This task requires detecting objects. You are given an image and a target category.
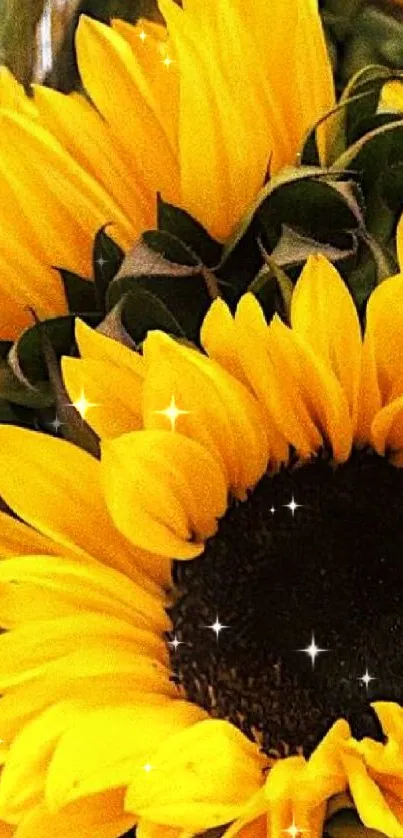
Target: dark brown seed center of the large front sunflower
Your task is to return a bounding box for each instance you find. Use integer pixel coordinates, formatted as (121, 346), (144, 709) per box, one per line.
(170, 453), (403, 756)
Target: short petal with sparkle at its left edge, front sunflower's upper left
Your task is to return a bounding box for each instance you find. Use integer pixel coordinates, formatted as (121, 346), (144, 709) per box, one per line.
(62, 357), (143, 439)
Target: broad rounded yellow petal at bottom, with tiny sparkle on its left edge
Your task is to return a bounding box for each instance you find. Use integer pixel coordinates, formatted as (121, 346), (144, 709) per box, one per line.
(125, 719), (267, 832)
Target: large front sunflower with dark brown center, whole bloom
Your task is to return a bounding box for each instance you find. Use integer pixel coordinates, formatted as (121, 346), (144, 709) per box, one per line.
(0, 256), (403, 838)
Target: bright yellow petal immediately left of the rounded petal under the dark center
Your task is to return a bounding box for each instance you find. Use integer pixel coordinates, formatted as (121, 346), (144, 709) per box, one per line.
(46, 700), (208, 809)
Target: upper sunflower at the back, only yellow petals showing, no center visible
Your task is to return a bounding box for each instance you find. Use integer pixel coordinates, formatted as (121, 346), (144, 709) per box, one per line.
(0, 0), (334, 339)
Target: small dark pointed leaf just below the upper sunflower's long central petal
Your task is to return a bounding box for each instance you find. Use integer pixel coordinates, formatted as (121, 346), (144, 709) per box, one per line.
(157, 195), (222, 268)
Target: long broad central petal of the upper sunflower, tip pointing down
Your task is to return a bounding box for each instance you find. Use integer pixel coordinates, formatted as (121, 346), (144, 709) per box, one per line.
(159, 0), (271, 240)
